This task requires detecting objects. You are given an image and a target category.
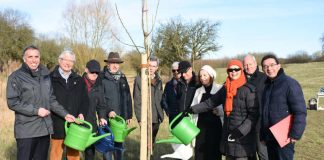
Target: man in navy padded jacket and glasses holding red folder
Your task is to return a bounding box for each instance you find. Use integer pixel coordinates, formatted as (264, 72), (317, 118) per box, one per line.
(261, 54), (306, 160)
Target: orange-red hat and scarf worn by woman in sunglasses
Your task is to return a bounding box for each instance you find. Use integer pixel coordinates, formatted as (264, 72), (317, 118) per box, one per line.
(224, 60), (246, 116)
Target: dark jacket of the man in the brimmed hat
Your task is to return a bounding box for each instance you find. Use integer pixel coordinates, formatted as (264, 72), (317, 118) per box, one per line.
(100, 67), (133, 119)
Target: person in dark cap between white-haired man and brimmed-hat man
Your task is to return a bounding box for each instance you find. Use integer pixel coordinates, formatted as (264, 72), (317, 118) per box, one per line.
(82, 59), (107, 160)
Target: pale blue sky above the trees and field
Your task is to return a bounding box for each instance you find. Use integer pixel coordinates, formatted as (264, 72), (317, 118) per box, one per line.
(0, 0), (324, 59)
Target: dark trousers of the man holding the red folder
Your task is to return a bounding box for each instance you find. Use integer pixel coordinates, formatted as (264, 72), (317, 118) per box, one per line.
(266, 141), (295, 160)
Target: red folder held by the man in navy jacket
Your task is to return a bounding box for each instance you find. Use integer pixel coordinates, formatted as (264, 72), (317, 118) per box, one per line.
(269, 114), (293, 148)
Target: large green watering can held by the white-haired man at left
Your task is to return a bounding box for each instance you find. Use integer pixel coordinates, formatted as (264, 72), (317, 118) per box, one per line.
(64, 118), (110, 151)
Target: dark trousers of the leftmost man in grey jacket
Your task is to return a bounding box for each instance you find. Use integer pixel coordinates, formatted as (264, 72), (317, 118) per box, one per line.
(16, 135), (50, 160)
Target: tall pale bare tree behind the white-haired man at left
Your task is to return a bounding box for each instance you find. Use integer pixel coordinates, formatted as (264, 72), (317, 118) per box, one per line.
(63, 0), (114, 69)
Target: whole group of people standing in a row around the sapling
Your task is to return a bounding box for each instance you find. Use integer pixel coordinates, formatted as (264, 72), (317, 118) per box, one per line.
(7, 45), (306, 160)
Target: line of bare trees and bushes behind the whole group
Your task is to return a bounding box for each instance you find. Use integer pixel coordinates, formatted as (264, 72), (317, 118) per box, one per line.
(0, 4), (324, 74)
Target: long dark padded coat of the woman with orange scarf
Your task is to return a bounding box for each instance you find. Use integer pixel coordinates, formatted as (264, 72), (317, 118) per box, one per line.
(192, 83), (259, 157)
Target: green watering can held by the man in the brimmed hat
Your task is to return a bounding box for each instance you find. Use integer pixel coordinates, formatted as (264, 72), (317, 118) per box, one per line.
(109, 115), (136, 142)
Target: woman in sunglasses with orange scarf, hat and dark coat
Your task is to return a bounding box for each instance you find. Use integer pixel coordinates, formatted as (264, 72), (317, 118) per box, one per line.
(189, 60), (259, 160)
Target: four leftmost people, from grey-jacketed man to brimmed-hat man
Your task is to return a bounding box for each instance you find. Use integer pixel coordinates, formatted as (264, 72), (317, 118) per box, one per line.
(7, 45), (133, 160)
